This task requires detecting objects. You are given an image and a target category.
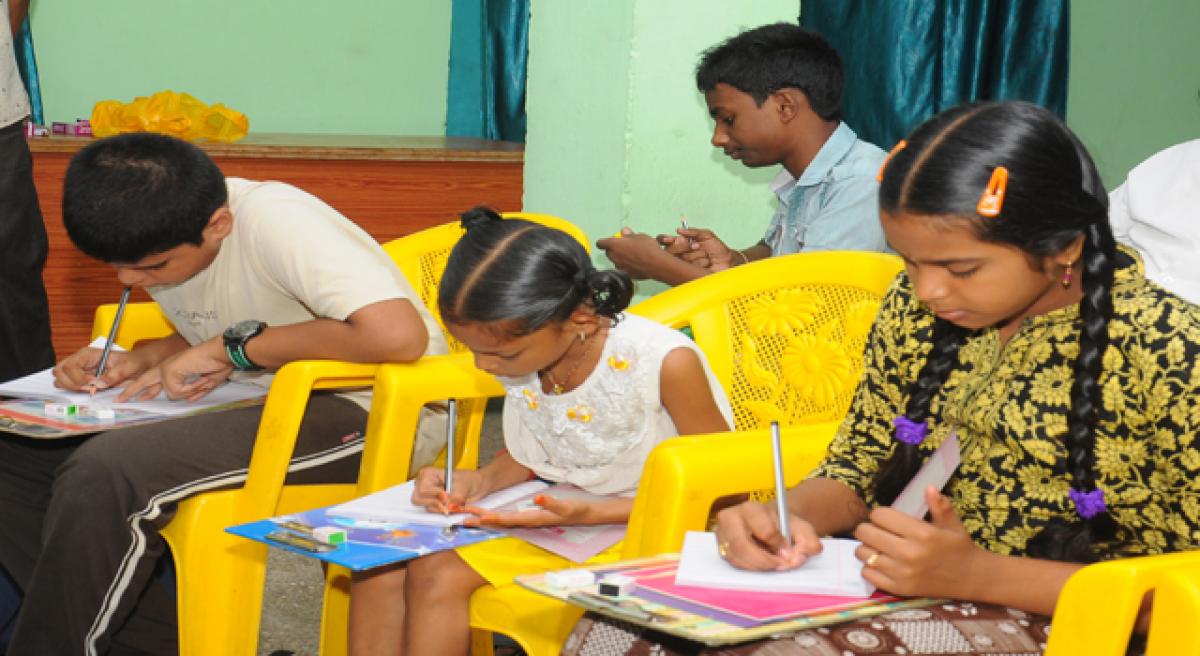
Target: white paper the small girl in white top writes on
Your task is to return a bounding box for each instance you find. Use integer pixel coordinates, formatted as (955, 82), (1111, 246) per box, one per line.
(328, 481), (550, 526)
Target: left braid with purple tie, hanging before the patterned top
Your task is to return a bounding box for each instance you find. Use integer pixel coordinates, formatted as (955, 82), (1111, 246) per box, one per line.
(875, 319), (970, 505)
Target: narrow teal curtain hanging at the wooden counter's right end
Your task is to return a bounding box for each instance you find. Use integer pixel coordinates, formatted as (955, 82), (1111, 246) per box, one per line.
(446, 0), (529, 142)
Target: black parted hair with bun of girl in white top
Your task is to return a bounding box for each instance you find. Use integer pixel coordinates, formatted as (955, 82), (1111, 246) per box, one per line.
(438, 206), (634, 336)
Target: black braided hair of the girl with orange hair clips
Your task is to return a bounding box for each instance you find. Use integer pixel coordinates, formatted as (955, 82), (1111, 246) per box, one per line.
(875, 102), (1117, 562)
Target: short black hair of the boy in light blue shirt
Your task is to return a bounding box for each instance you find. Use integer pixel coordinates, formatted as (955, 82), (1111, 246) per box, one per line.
(696, 23), (842, 121)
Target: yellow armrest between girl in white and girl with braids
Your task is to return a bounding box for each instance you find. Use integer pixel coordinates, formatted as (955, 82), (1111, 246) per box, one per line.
(623, 422), (838, 558)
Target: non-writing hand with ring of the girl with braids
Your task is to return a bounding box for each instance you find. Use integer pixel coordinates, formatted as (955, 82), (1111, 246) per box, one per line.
(854, 486), (989, 598)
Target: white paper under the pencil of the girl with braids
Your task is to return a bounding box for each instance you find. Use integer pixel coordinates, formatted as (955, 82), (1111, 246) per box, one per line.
(676, 531), (875, 597)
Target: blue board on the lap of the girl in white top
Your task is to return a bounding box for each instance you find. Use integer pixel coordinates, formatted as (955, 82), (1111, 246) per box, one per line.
(226, 506), (504, 572)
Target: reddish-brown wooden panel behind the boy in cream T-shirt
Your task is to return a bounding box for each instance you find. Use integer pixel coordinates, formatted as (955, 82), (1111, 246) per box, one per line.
(31, 136), (523, 359)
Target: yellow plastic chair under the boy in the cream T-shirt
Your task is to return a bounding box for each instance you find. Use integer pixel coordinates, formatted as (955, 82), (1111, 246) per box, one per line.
(84, 217), (530, 656)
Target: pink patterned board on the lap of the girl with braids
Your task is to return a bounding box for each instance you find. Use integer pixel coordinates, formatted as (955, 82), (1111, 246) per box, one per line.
(516, 554), (938, 646)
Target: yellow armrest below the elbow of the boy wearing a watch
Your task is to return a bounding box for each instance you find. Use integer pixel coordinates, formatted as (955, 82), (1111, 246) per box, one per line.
(234, 360), (379, 523)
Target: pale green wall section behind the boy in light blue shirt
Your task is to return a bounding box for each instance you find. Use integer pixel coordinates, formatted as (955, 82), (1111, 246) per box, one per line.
(524, 0), (798, 295)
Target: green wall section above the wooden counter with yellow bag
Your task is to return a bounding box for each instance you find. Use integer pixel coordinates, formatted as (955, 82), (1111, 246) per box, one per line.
(31, 0), (450, 134)
